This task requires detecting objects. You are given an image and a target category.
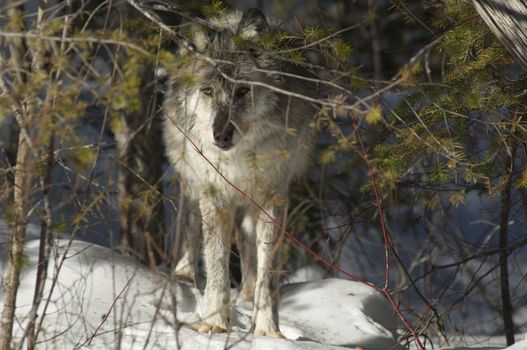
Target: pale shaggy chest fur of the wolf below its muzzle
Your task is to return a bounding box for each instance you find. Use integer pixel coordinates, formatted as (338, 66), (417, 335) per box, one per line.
(165, 121), (306, 205)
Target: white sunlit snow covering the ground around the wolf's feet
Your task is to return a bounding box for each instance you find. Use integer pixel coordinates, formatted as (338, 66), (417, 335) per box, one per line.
(0, 240), (527, 350)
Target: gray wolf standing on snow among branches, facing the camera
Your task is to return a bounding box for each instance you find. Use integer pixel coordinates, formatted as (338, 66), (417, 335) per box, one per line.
(164, 9), (317, 337)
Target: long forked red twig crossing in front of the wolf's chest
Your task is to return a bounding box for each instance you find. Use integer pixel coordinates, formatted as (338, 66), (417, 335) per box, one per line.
(167, 116), (424, 350)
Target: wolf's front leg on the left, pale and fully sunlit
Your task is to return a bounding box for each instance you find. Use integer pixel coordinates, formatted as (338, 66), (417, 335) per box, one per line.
(198, 199), (234, 333)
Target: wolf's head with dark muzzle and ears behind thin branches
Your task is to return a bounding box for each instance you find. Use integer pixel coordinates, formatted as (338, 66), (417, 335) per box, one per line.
(171, 9), (281, 151)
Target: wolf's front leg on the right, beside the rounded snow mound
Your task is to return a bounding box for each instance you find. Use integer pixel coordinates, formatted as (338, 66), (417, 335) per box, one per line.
(253, 208), (282, 337)
